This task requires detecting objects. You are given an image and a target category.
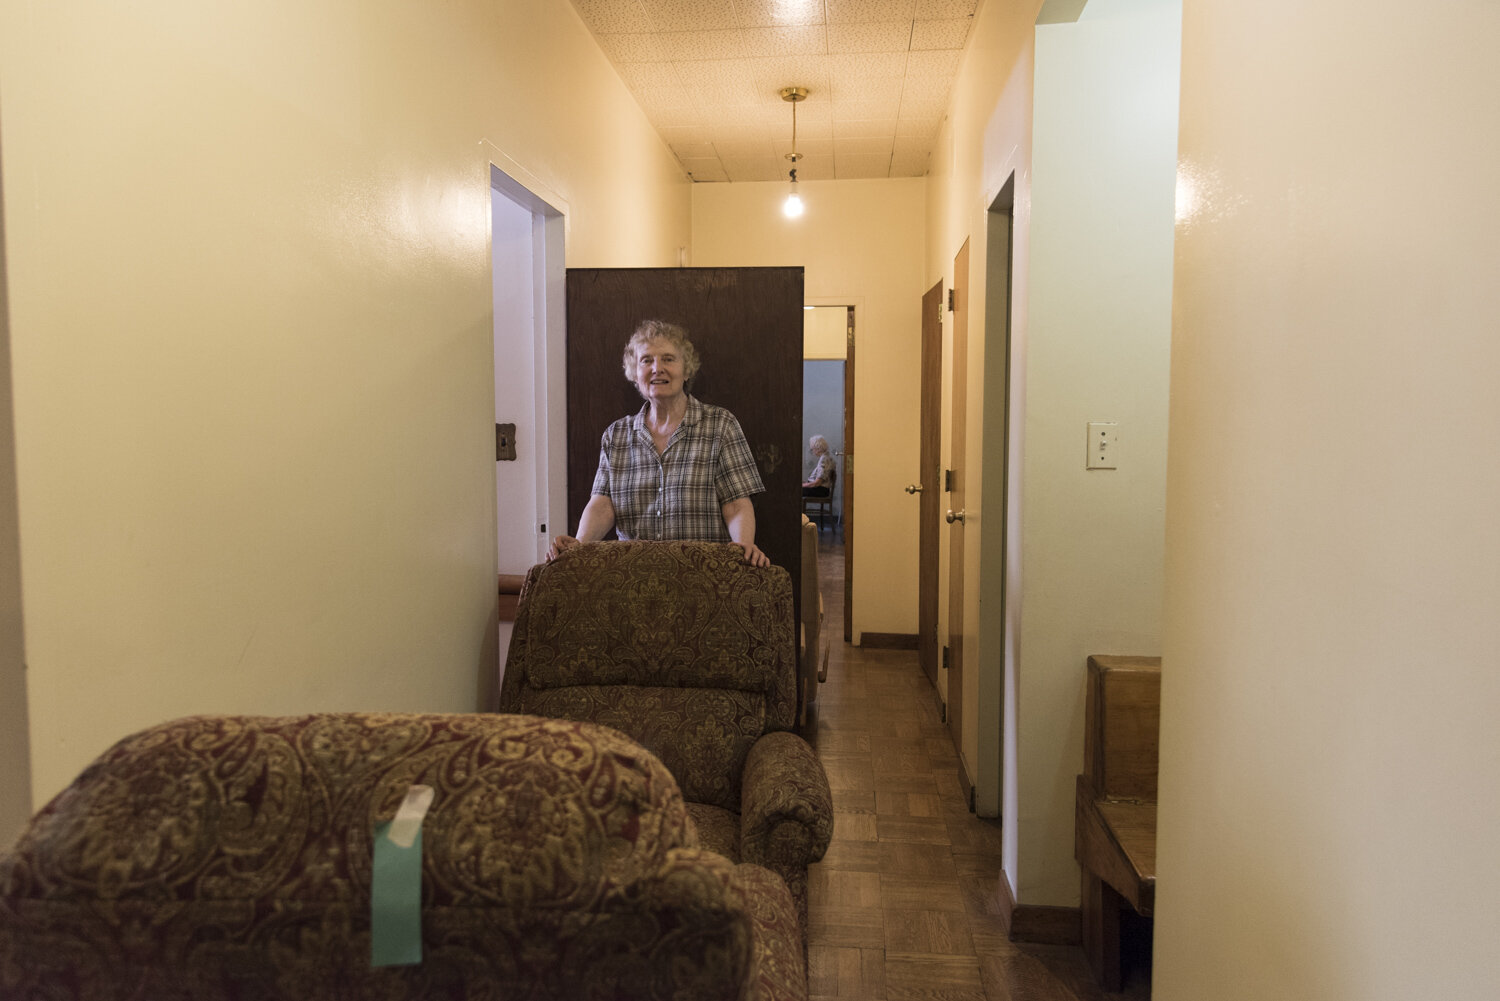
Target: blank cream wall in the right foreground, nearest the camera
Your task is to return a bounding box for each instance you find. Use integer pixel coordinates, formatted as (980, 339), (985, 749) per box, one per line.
(1154, 0), (1500, 1001)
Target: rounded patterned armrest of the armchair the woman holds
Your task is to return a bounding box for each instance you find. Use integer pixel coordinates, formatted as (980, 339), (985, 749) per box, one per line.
(740, 731), (834, 872)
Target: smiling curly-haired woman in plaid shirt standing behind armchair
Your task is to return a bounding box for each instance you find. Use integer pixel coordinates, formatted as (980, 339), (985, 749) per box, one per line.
(548, 320), (771, 567)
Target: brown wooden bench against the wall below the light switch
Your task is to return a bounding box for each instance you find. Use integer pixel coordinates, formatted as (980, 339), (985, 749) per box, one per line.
(1073, 656), (1161, 990)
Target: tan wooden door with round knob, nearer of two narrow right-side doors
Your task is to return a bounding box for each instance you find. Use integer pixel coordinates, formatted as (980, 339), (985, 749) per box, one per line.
(945, 240), (969, 759)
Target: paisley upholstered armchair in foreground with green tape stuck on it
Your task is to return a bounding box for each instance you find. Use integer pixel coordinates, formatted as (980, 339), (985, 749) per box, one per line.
(0, 713), (807, 1001)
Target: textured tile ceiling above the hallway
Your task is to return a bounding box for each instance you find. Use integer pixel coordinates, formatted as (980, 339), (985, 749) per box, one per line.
(573, 0), (980, 182)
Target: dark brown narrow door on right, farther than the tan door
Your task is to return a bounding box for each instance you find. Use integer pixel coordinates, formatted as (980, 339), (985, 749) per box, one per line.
(908, 279), (942, 687)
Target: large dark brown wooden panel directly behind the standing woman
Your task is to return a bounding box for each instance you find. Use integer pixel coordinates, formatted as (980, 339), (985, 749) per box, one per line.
(566, 267), (803, 590)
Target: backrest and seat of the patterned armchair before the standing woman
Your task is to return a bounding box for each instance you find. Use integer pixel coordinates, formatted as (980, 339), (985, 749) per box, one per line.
(500, 542), (797, 810)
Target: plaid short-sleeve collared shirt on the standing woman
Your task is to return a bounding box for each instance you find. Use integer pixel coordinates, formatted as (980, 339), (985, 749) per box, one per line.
(593, 396), (765, 542)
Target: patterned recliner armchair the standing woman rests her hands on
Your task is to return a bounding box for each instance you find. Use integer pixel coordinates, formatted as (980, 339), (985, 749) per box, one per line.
(500, 542), (833, 941)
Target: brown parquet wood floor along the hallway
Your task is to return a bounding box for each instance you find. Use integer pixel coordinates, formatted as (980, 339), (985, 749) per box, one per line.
(809, 531), (1151, 1001)
